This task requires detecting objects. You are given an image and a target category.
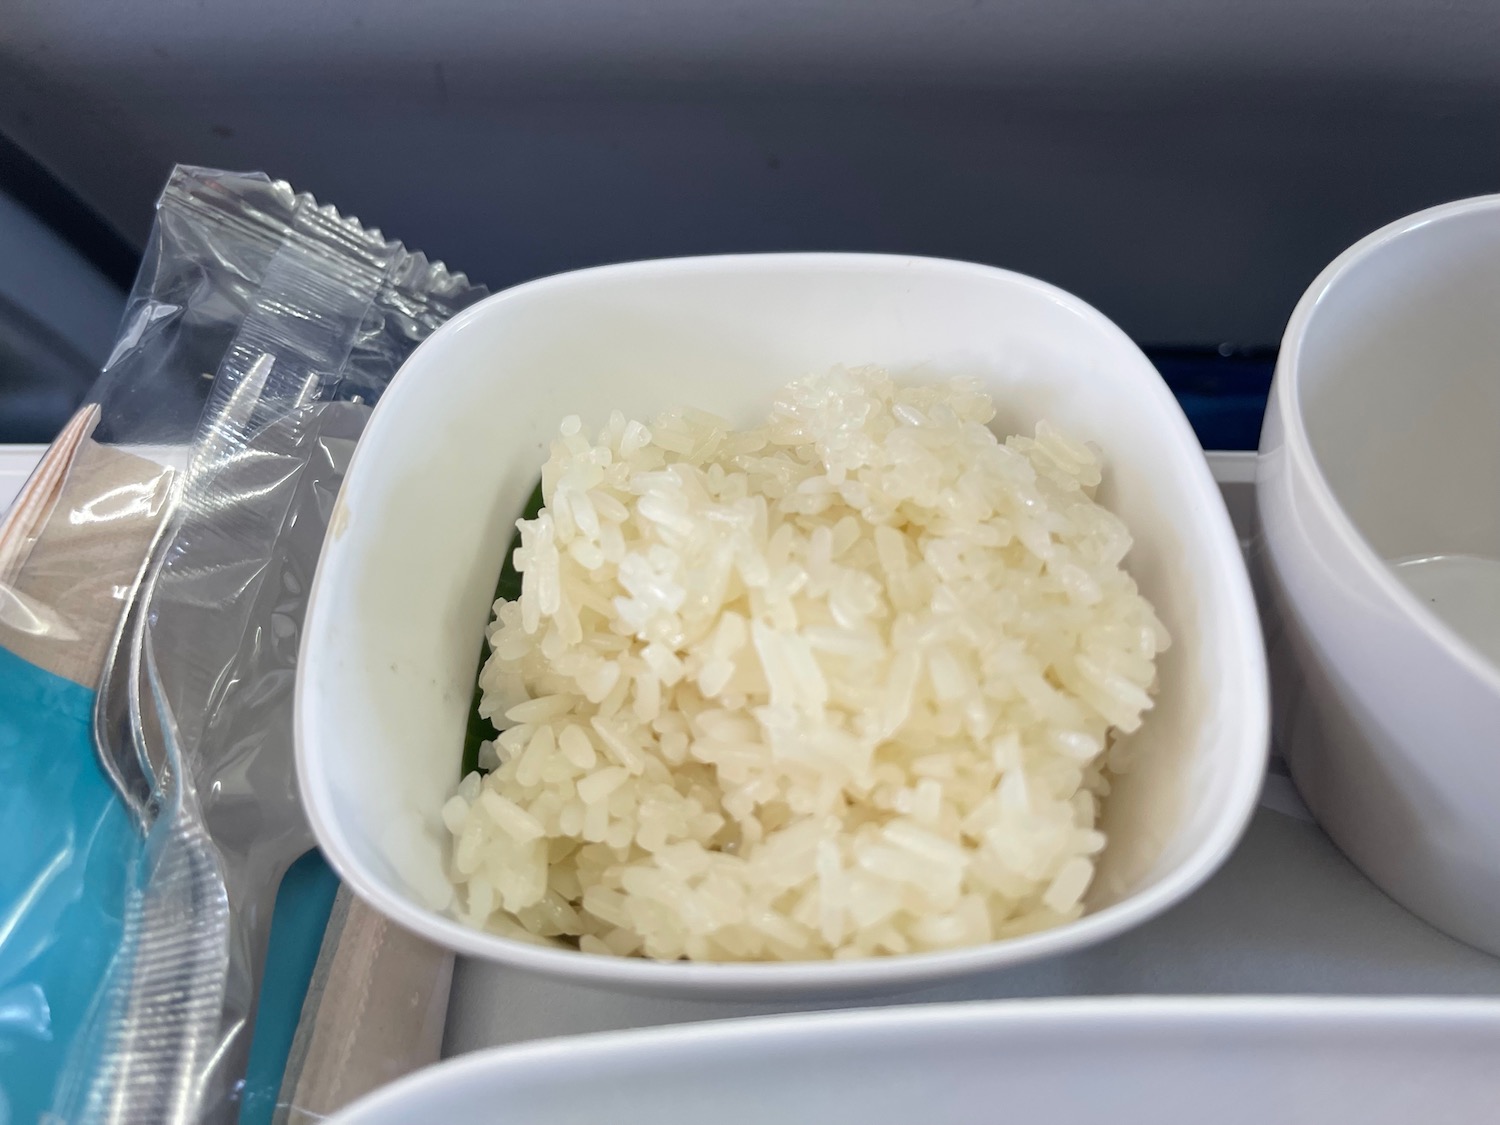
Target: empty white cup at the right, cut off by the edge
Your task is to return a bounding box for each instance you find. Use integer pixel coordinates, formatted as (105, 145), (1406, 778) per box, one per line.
(1257, 197), (1500, 954)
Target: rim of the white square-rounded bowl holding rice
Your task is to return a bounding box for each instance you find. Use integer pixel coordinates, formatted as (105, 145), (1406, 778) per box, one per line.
(294, 252), (1271, 996)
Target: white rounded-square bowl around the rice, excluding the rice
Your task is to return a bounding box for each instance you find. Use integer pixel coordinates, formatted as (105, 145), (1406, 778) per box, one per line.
(297, 255), (1268, 995)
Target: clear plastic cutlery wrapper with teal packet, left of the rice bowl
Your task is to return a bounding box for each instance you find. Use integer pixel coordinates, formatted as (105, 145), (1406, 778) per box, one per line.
(0, 168), (483, 1125)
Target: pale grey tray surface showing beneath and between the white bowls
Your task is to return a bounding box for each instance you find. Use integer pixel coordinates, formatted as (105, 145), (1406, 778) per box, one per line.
(444, 453), (1500, 1055)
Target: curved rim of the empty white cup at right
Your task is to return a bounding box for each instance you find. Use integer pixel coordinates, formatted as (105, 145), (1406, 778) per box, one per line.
(1257, 194), (1500, 696)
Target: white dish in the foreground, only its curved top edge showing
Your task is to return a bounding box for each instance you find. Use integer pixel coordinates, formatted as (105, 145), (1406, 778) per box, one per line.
(330, 998), (1500, 1125)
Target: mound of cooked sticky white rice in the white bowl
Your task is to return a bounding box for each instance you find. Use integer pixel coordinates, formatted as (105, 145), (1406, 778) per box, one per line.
(443, 369), (1169, 962)
